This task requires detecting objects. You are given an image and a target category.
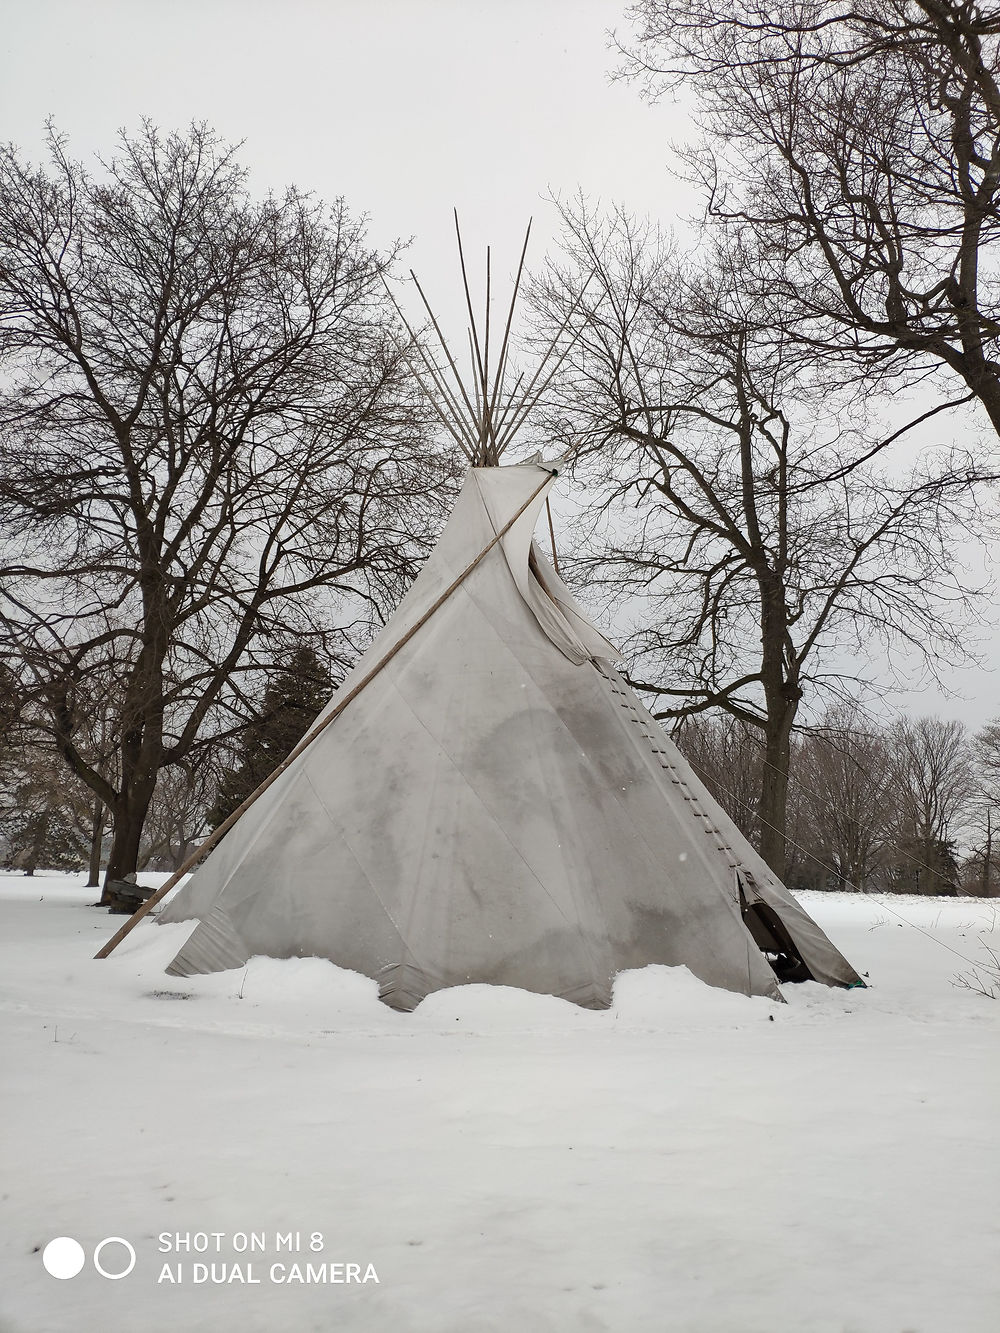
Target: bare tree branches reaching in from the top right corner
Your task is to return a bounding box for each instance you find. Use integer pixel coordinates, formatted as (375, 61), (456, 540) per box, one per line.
(619, 0), (1000, 433)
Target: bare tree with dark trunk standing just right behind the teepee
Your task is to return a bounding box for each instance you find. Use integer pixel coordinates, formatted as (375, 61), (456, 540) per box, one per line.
(536, 205), (979, 874)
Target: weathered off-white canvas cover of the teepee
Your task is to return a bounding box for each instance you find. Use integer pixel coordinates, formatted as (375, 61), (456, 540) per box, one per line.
(160, 464), (860, 1009)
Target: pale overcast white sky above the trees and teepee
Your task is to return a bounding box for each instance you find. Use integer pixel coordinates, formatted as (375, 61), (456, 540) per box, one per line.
(0, 0), (1000, 725)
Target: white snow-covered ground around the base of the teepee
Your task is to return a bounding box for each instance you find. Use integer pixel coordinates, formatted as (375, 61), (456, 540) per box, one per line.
(0, 876), (1000, 1333)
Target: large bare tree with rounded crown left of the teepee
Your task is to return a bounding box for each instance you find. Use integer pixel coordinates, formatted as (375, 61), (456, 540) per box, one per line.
(0, 124), (449, 900)
